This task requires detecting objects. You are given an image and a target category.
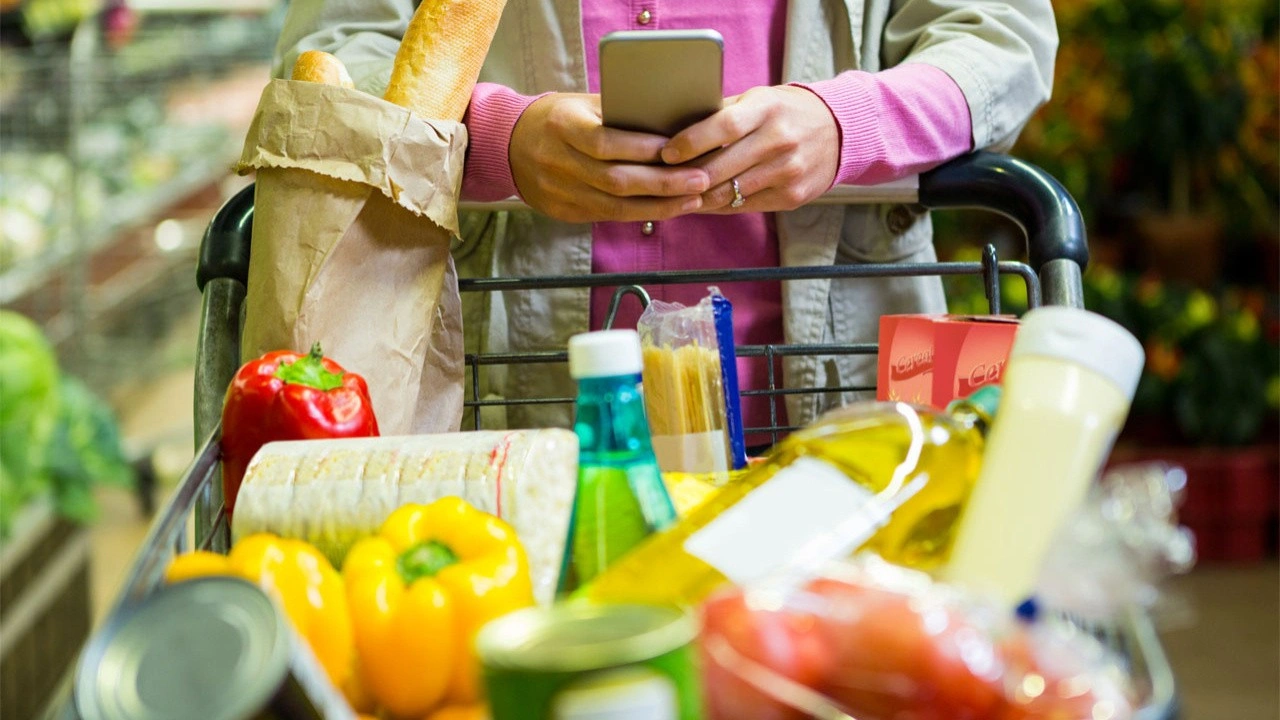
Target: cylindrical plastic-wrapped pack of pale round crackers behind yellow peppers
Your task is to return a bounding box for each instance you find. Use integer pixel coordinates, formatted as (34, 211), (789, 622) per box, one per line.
(232, 429), (577, 602)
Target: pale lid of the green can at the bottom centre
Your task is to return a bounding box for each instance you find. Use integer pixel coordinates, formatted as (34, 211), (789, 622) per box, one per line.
(476, 602), (698, 673)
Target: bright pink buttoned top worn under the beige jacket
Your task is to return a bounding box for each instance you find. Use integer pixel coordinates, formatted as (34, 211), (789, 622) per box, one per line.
(462, 0), (972, 445)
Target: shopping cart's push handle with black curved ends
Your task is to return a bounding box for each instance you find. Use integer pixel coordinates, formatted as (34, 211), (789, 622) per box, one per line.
(196, 150), (1089, 291)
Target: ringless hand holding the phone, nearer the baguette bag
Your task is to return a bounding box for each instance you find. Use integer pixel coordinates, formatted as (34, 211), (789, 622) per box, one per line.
(508, 94), (712, 223)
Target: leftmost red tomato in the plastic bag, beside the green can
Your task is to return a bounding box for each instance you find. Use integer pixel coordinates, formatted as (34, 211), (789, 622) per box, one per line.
(700, 591), (833, 720)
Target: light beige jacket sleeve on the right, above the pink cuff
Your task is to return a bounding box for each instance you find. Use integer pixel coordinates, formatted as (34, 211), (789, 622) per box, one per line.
(882, 0), (1057, 150)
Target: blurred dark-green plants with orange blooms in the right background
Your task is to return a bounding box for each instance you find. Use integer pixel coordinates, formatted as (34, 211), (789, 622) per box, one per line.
(934, 0), (1280, 446)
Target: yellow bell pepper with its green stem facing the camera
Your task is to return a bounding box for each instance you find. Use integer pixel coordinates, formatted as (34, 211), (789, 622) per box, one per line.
(342, 497), (534, 717)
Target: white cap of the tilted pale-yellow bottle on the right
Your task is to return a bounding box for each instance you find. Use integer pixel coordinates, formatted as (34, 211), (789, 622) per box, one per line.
(1009, 306), (1146, 401)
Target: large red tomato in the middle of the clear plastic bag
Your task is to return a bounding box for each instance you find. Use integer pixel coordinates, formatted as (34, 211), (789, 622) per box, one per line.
(809, 579), (1001, 720)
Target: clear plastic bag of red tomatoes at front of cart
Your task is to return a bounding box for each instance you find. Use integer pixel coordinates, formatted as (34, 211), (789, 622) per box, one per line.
(699, 557), (1134, 720)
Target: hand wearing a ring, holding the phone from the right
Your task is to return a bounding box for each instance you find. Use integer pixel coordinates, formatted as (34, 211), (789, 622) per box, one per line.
(662, 86), (840, 213)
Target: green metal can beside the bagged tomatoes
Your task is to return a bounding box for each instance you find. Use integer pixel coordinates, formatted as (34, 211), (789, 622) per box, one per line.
(476, 603), (701, 720)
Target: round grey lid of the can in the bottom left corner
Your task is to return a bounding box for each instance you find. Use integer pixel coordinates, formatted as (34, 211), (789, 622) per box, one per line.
(76, 577), (292, 720)
